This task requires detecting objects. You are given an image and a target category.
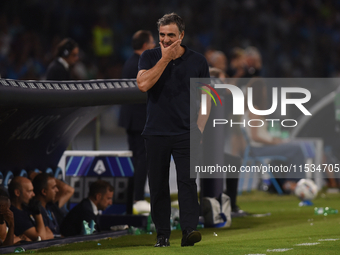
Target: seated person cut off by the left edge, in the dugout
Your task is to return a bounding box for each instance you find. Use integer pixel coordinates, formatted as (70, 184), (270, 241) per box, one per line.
(0, 189), (14, 246)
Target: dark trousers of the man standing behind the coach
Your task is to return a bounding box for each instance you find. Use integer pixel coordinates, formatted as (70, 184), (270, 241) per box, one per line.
(127, 131), (147, 200)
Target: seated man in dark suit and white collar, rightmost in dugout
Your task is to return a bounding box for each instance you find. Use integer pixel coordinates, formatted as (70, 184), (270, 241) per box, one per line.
(60, 180), (113, 236)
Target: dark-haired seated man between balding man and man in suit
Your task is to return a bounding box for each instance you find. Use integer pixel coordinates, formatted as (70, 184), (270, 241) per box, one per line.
(33, 173), (60, 237)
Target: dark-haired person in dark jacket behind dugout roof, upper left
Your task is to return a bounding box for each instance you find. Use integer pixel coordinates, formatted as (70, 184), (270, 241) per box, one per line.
(46, 38), (79, 81)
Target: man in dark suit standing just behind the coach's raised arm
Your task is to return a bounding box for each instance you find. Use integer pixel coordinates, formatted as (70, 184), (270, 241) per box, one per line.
(119, 30), (155, 213)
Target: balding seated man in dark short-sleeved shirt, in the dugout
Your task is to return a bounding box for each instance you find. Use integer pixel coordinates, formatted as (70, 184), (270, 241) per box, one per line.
(8, 176), (54, 241)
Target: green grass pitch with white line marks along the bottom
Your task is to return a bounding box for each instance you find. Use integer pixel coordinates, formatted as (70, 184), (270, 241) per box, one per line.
(19, 191), (340, 255)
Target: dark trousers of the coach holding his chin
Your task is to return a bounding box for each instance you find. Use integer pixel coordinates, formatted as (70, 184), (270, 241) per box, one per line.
(144, 133), (199, 237)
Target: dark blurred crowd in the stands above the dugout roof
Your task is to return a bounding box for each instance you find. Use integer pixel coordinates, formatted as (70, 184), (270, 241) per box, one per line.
(0, 0), (340, 79)
